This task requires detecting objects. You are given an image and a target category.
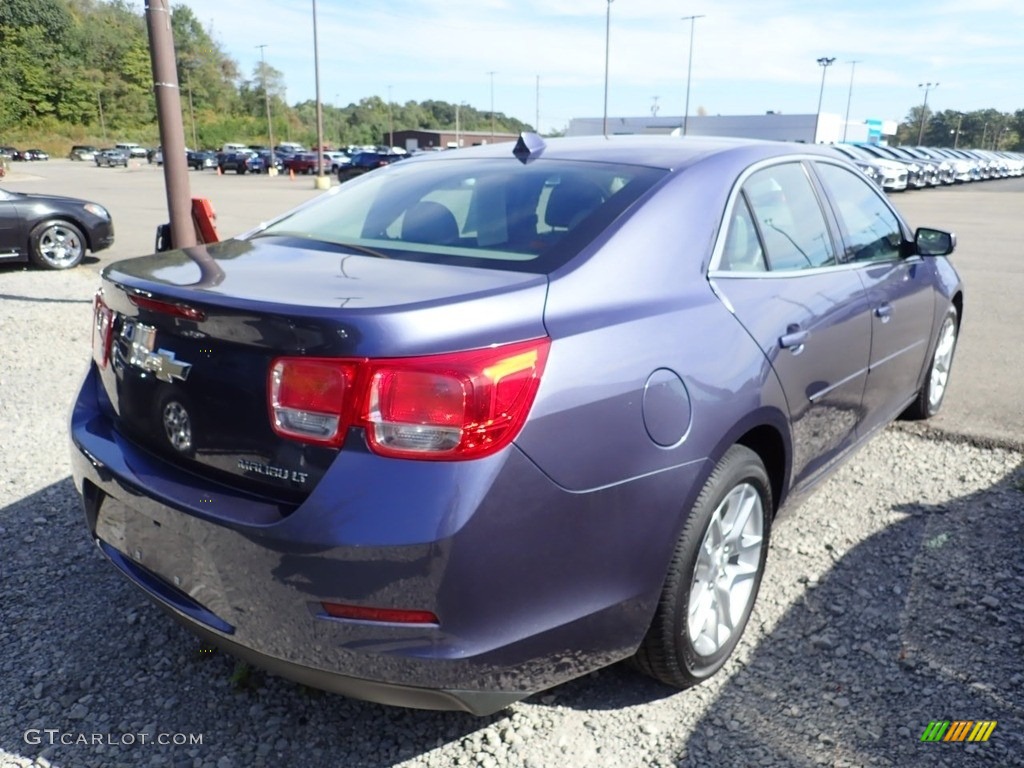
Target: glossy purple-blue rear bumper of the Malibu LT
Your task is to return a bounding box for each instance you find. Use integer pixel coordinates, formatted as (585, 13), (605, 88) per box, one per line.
(71, 372), (698, 715)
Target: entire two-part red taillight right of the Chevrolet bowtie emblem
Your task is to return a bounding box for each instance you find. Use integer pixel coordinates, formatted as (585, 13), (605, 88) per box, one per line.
(270, 338), (550, 460)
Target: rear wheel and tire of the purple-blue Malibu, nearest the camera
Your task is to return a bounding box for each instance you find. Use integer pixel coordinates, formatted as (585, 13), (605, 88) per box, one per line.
(633, 445), (773, 688)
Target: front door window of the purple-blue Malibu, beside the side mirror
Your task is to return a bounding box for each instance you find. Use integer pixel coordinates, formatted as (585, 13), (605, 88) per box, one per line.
(818, 163), (903, 261)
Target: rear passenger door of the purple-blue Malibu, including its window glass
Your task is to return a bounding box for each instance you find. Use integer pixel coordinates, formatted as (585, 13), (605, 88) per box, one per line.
(711, 161), (871, 484)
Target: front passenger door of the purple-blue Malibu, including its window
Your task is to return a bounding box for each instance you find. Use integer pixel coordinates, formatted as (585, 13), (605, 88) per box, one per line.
(815, 163), (935, 431)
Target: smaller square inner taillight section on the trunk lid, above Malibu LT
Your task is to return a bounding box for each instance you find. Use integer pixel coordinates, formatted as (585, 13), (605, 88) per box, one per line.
(269, 357), (359, 446)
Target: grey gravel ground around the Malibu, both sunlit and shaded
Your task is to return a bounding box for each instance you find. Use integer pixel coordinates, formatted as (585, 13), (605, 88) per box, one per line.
(0, 268), (1024, 768)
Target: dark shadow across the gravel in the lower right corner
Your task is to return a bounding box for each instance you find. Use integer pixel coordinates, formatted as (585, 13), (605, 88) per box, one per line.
(676, 460), (1024, 767)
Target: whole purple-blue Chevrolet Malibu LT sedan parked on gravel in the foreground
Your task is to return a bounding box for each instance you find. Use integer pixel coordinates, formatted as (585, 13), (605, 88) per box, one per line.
(71, 134), (964, 714)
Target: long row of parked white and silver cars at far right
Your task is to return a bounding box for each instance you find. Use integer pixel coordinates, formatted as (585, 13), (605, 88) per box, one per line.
(833, 143), (1024, 191)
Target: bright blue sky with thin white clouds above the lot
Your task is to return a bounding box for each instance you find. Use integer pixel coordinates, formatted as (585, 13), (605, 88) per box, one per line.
(185, 0), (1024, 132)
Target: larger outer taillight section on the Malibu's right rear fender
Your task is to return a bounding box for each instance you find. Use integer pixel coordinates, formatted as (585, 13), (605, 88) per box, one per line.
(361, 339), (550, 459)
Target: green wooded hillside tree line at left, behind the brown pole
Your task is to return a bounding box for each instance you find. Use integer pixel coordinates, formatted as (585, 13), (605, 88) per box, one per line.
(0, 0), (530, 152)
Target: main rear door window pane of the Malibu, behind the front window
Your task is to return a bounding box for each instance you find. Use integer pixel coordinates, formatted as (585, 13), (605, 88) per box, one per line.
(742, 163), (836, 271)
